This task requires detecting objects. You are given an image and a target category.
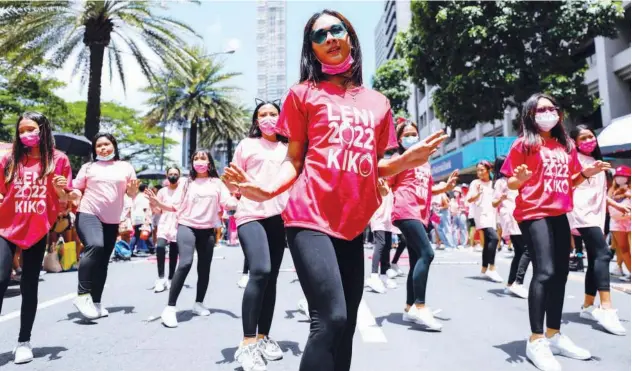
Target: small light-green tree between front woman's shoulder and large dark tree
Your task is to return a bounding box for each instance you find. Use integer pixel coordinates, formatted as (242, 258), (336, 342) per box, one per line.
(373, 59), (410, 117)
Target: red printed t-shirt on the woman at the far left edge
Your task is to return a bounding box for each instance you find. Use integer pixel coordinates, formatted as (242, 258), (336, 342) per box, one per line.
(0, 150), (72, 250)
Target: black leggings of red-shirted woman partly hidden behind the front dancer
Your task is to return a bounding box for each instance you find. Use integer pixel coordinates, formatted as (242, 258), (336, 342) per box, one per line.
(394, 219), (434, 305)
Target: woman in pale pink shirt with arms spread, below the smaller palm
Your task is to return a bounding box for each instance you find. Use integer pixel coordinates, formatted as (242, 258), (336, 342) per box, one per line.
(145, 150), (236, 328)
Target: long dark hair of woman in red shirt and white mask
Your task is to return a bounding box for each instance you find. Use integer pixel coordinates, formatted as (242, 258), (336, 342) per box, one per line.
(520, 93), (573, 154)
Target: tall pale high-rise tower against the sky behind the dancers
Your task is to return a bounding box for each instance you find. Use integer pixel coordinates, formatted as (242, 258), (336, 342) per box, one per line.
(257, 0), (286, 100)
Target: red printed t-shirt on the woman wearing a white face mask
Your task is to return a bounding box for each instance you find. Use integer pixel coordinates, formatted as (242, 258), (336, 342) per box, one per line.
(500, 137), (582, 222)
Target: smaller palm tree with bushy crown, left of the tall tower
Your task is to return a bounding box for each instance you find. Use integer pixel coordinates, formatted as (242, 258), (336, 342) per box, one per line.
(145, 49), (246, 160)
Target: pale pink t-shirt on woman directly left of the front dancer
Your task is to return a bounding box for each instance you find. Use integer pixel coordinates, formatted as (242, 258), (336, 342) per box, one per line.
(233, 138), (289, 226)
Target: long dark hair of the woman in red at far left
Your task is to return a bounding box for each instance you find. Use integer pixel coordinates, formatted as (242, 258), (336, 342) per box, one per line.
(4, 111), (55, 184)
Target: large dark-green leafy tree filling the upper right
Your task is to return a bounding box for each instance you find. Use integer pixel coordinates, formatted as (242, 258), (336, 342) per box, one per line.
(397, 0), (623, 129)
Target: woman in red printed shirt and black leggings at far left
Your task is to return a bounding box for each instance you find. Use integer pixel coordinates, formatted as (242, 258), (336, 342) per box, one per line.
(0, 112), (72, 364)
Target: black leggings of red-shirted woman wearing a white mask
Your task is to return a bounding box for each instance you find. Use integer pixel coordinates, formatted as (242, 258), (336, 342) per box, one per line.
(519, 214), (571, 334)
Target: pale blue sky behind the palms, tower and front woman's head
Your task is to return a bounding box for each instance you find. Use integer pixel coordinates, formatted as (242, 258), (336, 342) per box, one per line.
(55, 0), (384, 166)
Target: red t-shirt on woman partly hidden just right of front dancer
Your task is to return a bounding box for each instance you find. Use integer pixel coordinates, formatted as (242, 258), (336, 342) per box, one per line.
(390, 163), (434, 227)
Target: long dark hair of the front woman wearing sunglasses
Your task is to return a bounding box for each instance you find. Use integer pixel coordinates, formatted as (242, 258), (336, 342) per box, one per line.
(300, 9), (362, 86)
